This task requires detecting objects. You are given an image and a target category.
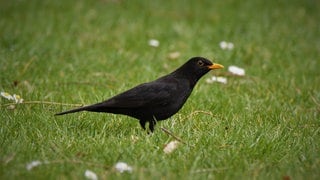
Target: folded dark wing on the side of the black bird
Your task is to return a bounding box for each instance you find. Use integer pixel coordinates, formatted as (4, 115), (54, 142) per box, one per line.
(101, 81), (178, 108)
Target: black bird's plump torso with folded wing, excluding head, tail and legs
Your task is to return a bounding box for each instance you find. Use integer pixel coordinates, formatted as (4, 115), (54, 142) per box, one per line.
(88, 76), (192, 120)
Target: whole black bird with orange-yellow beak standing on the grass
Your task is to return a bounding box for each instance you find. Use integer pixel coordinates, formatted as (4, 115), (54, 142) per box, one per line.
(55, 57), (223, 132)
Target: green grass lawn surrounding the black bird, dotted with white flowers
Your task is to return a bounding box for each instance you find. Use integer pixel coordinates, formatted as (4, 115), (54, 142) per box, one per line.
(0, 0), (320, 179)
